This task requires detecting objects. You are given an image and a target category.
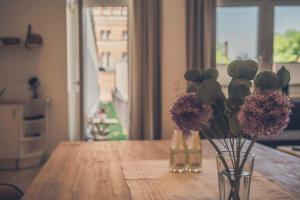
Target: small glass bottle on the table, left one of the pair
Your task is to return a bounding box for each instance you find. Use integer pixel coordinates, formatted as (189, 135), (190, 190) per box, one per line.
(170, 129), (186, 173)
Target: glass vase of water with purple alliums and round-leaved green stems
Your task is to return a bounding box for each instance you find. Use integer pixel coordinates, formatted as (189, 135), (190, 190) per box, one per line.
(170, 60), (292, 200)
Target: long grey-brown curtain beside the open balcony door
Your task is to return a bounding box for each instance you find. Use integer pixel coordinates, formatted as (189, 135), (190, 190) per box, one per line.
(129, 0), (161, 139)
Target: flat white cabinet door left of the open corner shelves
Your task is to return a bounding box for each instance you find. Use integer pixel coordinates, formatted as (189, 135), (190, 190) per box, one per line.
(0, 105), (20, 159)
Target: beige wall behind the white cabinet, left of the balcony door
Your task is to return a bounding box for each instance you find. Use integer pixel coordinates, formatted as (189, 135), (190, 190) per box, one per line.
(0, 0), (68, 150)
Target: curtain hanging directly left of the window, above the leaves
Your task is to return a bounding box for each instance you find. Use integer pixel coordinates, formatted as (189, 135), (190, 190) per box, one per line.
(186, 0), (217, 69)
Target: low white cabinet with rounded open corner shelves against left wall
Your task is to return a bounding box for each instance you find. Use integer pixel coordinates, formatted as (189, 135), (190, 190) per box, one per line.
(0, 100), (48, 169)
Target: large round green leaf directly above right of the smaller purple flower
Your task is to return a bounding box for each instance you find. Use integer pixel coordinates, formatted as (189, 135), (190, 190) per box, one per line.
(197, 79), (222, 105)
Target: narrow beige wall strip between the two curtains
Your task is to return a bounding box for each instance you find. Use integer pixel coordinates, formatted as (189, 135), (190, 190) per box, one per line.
(162, 0), (187, 139)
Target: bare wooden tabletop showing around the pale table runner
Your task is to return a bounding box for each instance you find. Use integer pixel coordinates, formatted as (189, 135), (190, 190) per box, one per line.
(23, 140), (300, 200)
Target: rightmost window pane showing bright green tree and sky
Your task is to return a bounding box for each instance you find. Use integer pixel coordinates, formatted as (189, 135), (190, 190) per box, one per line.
(273, 6), (300, 63)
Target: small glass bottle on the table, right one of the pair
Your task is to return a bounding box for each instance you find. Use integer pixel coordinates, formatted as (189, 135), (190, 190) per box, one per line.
(187, 131), (202, 172)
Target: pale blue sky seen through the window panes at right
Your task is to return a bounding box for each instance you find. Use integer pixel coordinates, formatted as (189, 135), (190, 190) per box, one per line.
(217, 6), (300, 60)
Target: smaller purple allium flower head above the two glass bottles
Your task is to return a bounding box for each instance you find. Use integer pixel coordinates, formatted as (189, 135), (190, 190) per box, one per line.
(170, 93), (213, 133)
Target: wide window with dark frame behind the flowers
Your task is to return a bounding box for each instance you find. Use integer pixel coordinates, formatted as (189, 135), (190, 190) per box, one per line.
(216, 0), (300, 92)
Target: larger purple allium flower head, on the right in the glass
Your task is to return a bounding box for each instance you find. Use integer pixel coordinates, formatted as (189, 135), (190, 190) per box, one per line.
(237, 89), (292, 139)
